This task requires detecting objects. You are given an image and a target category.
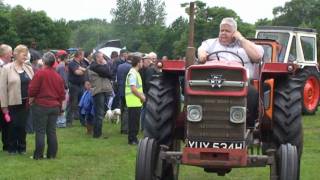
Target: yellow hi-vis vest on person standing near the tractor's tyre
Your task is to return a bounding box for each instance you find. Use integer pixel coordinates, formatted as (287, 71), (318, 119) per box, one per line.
(125, 68), (143, 107)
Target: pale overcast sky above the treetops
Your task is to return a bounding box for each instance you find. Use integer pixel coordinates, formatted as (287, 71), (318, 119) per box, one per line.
(3, 0), (289, 25)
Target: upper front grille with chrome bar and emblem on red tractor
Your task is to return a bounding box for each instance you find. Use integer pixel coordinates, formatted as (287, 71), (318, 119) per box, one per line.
(189, 68), (245, 92)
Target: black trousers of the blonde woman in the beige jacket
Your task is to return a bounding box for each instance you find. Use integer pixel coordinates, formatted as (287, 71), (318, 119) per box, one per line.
(7, 101), (29, 153)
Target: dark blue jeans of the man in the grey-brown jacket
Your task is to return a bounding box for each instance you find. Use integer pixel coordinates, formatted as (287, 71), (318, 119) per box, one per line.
(93, 92), (109, 138)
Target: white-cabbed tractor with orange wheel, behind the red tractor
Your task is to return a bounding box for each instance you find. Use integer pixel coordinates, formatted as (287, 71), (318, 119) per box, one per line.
(256, 26), (320, 114)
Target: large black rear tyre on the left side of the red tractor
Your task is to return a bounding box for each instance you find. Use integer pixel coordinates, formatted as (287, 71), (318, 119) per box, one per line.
(144, 76), (179, 147)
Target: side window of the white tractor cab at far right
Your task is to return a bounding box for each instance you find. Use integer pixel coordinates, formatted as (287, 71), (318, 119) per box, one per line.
(300, 36), (316, 61)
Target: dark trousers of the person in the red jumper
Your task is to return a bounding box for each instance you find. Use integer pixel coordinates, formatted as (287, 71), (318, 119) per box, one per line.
(33, 104), (60, 159)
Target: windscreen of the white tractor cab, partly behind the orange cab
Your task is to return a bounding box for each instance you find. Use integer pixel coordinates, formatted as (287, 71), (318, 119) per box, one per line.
(257, 32), (290, 62)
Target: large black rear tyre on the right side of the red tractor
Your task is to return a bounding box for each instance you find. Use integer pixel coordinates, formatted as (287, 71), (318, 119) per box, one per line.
(272, 77), (303, 159)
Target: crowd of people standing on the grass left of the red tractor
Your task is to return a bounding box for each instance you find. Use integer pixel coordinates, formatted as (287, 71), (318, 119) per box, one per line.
(0, 41), (158, 160)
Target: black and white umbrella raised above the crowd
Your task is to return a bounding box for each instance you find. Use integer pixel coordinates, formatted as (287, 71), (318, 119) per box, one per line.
(93, 39), (126, 59)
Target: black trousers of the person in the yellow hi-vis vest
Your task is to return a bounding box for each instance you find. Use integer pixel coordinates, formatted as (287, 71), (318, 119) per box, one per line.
(128, 107), (141, 143)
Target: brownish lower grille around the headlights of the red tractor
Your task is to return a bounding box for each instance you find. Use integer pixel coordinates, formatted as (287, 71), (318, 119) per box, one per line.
(186, 96), (246, 142)
